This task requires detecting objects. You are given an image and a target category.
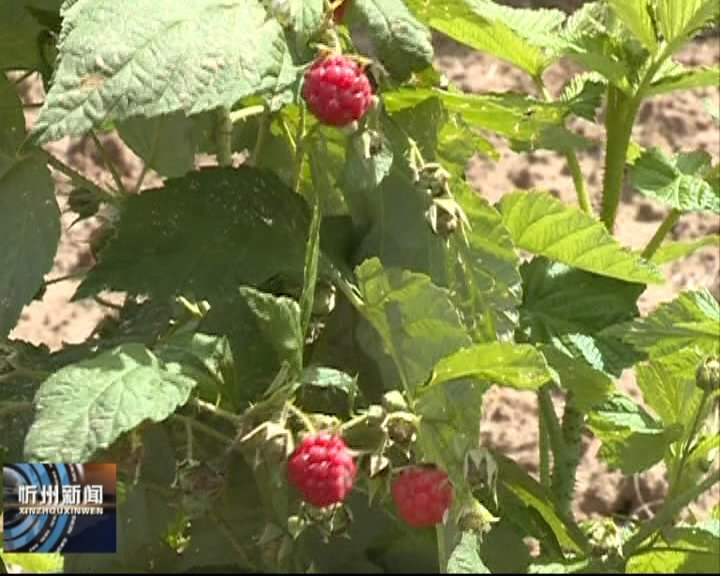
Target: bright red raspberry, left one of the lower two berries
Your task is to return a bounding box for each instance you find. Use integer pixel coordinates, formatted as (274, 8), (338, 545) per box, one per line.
(288, 432), (356, 508)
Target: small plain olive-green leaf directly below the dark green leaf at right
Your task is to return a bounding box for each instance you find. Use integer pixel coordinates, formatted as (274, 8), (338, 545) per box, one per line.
(540, 345), (615, 412)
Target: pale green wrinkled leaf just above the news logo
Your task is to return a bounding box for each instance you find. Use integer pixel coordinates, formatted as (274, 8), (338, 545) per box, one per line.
(25, 344), (195, 462)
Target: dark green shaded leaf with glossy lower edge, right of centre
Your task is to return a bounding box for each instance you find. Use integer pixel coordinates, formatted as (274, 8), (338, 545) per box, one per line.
(520, 258), (644, 384)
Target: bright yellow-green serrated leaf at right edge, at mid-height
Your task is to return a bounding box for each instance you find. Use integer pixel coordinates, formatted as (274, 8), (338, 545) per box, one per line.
(612, 289), (720, 357)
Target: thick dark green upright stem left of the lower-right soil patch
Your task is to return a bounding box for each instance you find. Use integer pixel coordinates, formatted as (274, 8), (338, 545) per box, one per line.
(552, 392), (585, 520)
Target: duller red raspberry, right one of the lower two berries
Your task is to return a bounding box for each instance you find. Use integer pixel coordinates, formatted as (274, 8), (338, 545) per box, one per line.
(390, 466), (452, 528)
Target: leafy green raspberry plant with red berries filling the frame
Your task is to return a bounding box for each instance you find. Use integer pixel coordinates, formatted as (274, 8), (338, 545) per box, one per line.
(0, 0), (720, 573)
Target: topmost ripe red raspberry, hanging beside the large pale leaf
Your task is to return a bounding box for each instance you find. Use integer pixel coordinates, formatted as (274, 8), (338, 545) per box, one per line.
(303, 55), (372, 126)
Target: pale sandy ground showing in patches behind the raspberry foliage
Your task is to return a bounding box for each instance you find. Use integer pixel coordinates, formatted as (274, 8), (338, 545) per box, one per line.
(7, 1), (720, 518)
